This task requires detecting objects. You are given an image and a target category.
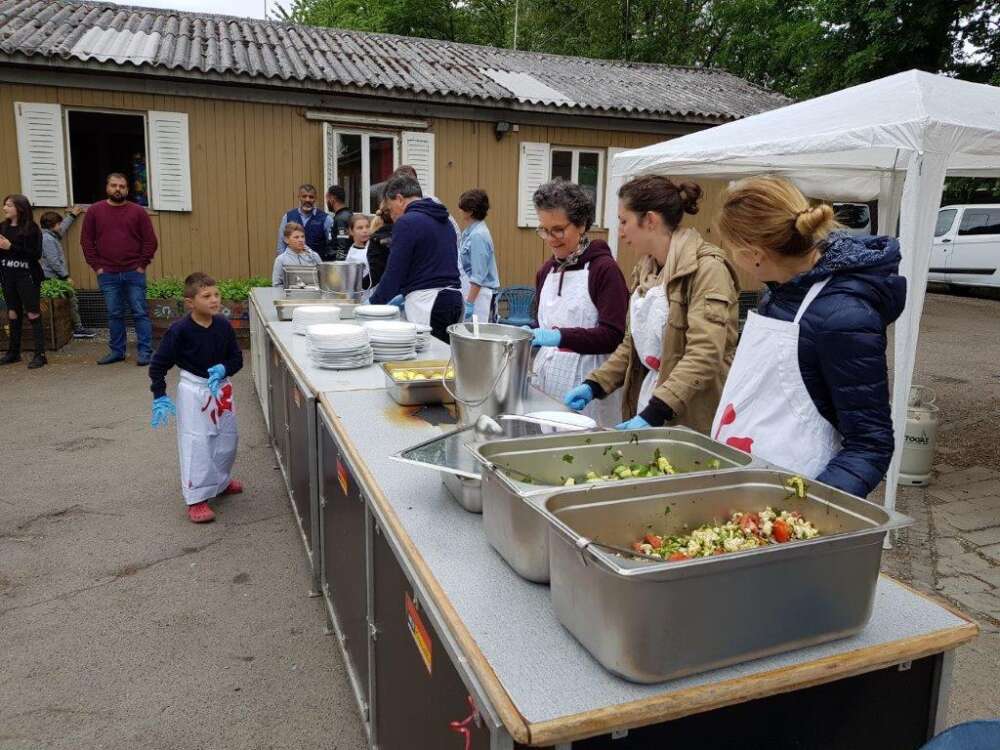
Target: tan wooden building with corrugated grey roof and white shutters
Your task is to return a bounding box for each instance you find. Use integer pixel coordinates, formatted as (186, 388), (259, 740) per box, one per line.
(0, 0), (785, 288)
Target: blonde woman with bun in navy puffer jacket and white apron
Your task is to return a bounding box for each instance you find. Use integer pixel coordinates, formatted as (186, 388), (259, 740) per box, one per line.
(712, 177), (906, 497)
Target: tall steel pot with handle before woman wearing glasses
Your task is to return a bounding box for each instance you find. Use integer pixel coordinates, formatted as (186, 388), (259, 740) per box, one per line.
(446, 323), (531, 425)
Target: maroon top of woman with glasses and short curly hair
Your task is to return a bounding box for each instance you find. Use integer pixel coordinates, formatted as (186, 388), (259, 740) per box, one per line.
(535, 240), (629, 354)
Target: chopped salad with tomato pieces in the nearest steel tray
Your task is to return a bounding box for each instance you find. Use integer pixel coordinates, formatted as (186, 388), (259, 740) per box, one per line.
(632, 506), (819, 561)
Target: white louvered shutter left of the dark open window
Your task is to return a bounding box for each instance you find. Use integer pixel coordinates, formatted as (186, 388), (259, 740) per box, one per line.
(14, 102), (69, 206)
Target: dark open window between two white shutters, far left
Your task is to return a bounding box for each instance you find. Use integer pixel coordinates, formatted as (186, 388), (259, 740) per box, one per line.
(66, 109), (150, 206)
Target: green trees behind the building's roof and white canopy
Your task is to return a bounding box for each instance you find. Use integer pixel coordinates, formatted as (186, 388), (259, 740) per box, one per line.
(276, 0), (1000, 99)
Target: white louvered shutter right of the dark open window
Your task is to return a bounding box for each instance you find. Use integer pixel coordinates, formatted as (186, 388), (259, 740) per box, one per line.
(149, 112), (191, 211)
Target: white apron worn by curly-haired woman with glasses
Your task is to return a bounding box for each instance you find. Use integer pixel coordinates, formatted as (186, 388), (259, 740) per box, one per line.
(533, 263), (622, 427)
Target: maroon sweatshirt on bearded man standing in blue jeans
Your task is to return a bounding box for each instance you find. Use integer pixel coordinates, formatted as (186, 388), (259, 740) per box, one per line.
(80, 201), (156, 273)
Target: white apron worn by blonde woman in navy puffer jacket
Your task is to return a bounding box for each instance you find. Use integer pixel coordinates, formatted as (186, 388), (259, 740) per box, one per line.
(712, 277), (841, 479)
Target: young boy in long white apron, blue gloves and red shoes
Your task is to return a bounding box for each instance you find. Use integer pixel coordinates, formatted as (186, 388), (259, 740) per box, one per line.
(149, 273), (243, 523)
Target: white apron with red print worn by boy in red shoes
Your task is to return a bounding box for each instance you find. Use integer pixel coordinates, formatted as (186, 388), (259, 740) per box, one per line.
(177, 370), (238, 505)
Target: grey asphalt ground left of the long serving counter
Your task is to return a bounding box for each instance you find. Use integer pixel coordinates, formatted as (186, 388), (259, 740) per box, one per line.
(0, 342), (365, 750)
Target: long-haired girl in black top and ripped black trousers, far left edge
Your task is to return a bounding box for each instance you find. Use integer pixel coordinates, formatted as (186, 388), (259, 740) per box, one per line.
(0, 195), (48, 370)
